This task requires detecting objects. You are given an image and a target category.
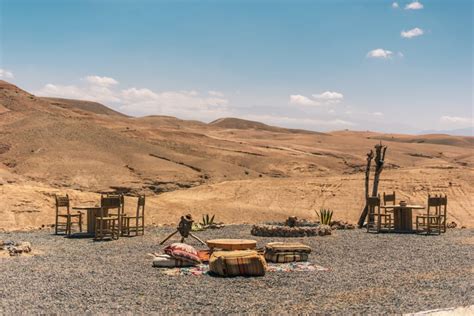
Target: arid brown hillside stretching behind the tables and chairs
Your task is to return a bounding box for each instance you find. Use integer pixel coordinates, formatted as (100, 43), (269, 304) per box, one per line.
(0, 81), (474, 230)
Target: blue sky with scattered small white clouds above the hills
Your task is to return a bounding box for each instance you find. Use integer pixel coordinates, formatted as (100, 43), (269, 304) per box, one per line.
(0, 0), (473, 132)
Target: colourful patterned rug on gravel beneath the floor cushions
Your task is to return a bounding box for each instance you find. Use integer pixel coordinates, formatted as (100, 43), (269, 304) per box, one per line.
(158, 262), (329, 276)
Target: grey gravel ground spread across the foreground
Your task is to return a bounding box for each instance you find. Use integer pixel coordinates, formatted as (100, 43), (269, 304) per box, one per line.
(0, 225), (474, 314)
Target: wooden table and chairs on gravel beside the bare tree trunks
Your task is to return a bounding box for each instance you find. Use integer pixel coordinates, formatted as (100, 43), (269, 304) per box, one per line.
(366, 192), (448, 235)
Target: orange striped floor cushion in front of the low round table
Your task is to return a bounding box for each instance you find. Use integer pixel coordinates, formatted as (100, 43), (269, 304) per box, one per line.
(209, 250), (267, 277)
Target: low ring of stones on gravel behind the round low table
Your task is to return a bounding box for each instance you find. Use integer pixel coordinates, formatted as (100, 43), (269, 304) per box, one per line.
(251, 224), (331, 237)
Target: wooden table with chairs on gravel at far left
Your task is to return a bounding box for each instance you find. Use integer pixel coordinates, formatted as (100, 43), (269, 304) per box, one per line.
(55, 193), (145, 240)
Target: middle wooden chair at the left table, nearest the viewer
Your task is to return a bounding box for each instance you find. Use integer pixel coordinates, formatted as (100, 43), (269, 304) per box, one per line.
(95, 195), (122, 240)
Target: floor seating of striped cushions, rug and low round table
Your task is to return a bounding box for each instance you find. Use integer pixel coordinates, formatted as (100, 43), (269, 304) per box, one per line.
(150, 239), (316, 277)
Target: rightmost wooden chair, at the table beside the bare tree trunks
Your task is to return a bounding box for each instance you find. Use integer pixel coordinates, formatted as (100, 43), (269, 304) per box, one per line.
(416, 194), (442, 235)
